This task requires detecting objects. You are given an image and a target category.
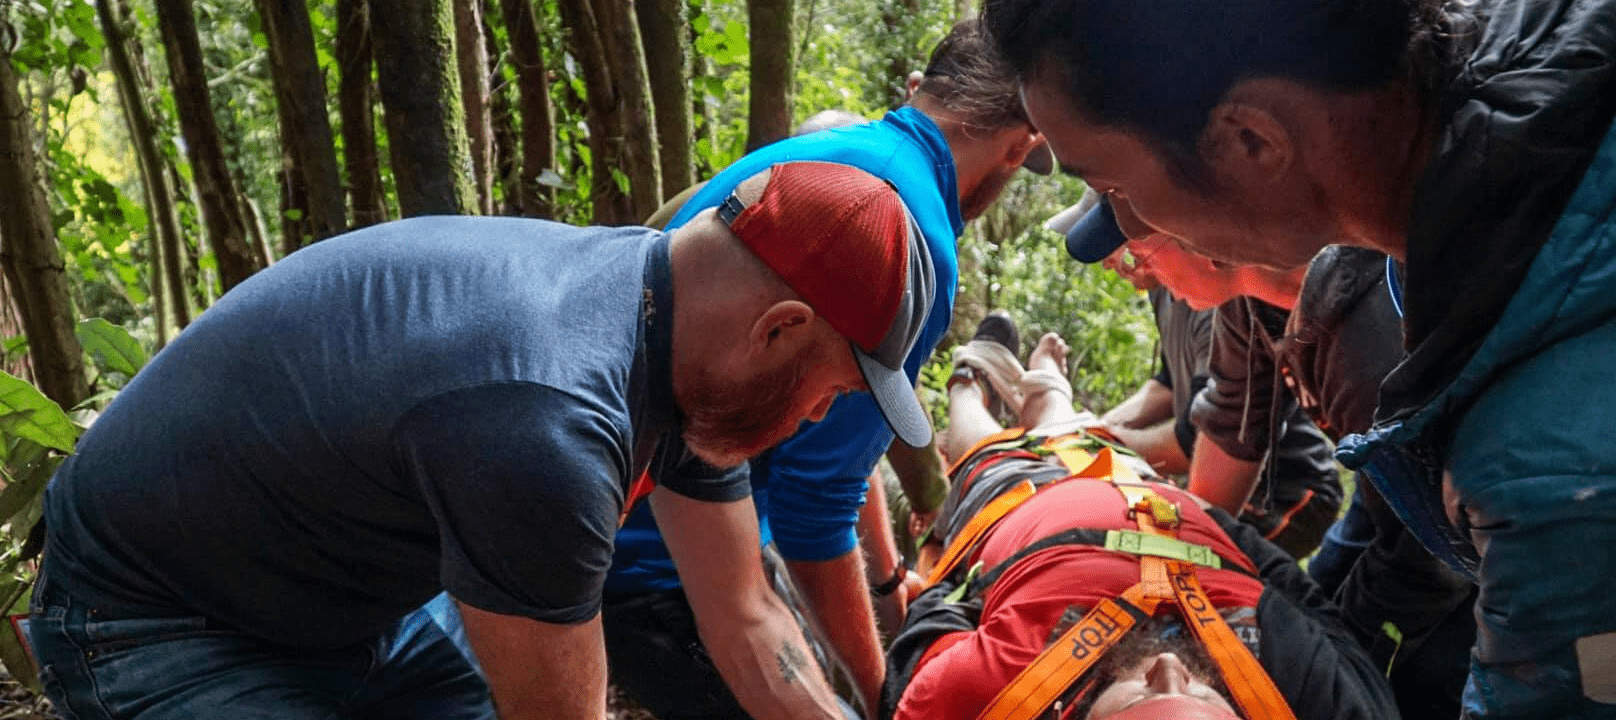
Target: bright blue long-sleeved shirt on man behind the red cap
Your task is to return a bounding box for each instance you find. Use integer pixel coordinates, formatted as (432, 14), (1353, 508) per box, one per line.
(606, 108), (965, 594)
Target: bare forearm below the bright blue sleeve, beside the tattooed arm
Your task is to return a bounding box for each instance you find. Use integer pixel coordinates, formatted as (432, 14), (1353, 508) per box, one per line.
(785, 549), (886, 709)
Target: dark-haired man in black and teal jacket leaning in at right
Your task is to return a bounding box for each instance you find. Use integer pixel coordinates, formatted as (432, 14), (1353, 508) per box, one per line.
(984, 0), (1616, 710)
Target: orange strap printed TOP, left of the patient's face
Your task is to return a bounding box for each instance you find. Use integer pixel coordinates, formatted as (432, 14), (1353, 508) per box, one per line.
(978, 583), (1160, 720)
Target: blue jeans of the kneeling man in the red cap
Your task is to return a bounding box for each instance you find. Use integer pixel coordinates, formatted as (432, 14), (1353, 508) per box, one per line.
(29, 560), (494, 720)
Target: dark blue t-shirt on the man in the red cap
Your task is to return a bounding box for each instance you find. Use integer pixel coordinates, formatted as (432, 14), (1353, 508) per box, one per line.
(45, 218), (748, 646)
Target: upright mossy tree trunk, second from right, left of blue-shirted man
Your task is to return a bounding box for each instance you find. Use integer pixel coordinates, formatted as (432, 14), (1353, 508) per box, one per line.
(633, 0), (695, 197)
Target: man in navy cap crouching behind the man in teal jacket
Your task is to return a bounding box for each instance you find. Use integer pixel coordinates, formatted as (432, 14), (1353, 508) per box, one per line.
(1062, 190), (1341, 559)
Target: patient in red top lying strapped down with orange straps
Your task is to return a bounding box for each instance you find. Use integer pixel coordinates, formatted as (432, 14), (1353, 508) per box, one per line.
(881, 334), (1398, 720)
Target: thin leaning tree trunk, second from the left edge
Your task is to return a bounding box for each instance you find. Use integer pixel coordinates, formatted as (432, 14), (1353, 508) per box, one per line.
(95, 0), (191, 345)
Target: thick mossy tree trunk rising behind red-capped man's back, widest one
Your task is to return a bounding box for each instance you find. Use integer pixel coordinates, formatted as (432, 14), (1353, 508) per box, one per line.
(370, 0), (477, 218)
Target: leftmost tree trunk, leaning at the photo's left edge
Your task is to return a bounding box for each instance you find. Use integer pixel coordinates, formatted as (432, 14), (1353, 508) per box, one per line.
(0, 40), (91, 408)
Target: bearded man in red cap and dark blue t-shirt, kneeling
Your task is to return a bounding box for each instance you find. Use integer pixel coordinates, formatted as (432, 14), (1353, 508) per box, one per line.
(31, 163), (936, 720)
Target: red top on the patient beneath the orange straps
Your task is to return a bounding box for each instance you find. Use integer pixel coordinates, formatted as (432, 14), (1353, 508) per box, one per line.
(895, 479), (1262, 720)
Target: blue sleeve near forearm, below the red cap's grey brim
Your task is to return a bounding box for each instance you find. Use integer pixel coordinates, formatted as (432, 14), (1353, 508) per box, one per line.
(753, 392), (892, 560)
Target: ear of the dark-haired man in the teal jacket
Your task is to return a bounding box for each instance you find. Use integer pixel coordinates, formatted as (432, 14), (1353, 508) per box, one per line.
(1201, 92), (1296, 184)
